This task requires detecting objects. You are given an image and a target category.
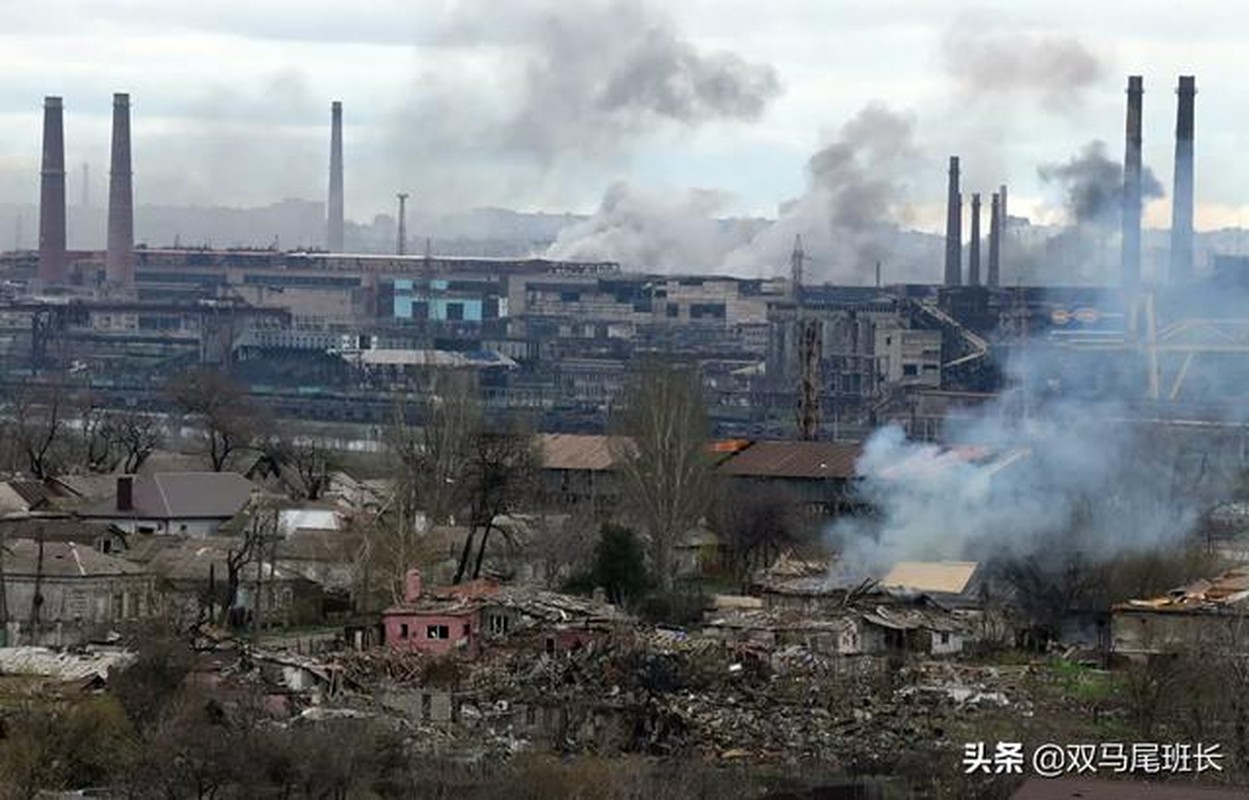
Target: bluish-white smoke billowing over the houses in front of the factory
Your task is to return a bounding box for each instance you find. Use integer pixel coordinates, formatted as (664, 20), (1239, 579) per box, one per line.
(832, 334), (1234, 575)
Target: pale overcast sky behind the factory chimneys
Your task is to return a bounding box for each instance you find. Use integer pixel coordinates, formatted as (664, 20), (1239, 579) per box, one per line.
(0, 0), (1249, 230)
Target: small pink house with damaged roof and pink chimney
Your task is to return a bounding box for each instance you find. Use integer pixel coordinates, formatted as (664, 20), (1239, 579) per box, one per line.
(382, 569), (497, 655)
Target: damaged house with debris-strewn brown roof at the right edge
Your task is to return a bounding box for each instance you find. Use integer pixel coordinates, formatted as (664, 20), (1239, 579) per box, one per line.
(1110, 567), (1249, 656)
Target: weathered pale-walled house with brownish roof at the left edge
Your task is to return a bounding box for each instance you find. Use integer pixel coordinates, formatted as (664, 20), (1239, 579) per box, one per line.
(4, 539), (159, 646)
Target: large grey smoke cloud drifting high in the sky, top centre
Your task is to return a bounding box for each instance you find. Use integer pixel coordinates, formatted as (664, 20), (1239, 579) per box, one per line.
(429, 0), (781, 163)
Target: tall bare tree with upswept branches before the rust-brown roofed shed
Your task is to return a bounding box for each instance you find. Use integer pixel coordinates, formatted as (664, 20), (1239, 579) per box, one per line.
(613, 364), (712, 590)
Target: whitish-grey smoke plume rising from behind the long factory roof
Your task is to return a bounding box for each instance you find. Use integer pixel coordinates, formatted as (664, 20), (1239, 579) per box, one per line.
(546, 105), (927, 283)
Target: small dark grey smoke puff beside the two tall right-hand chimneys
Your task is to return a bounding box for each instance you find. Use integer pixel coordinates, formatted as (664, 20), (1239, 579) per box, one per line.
(1037, 140), (1164, 228)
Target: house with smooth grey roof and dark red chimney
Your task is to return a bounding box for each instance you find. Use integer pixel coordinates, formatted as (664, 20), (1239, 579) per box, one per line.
(80, 472), (257, 537)
